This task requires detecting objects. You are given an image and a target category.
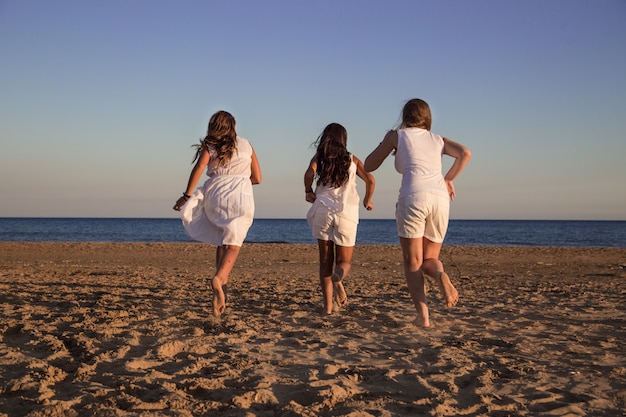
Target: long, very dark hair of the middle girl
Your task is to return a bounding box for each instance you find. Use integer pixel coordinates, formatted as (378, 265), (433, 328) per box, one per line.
(313, 123), (352, 187)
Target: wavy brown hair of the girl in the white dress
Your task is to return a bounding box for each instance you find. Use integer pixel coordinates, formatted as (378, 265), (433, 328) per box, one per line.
(193, 110), (237, 166)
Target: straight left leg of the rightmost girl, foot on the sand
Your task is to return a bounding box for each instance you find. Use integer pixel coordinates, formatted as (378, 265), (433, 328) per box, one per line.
(400, 237), (430, 327)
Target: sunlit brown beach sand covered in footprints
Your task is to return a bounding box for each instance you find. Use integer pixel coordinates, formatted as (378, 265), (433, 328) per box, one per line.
(0, 242), (626, 417)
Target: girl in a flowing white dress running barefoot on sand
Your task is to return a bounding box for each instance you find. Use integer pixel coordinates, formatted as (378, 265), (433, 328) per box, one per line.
(174, 111), (261, 317)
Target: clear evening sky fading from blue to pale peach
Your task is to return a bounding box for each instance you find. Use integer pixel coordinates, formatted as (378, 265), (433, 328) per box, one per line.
(0, 0), (626, 220)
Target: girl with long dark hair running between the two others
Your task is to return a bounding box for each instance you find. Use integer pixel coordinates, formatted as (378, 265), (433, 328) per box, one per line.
(304, 123), (375, 314)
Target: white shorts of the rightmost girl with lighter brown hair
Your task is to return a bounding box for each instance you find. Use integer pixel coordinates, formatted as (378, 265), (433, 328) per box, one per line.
(396, 193), (450, 243)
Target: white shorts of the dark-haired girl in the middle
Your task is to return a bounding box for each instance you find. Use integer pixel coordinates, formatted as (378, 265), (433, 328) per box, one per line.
(307, 204), (358, 246)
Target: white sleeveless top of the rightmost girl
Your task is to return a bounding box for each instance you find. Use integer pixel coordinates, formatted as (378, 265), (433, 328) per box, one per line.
(395, 127), (448, 197)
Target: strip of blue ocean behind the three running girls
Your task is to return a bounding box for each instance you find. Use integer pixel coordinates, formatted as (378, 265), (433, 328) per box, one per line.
(0, 217), (626, 248)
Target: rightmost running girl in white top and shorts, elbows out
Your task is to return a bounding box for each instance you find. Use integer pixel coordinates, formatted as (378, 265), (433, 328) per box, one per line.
(365, 98), (471, 327)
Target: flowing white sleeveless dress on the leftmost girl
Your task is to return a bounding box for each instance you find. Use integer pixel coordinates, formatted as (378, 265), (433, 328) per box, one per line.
(181, 136), (254, 246)
